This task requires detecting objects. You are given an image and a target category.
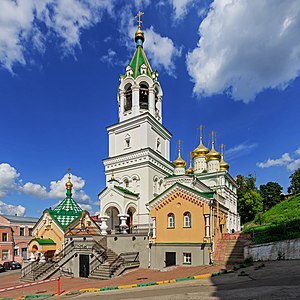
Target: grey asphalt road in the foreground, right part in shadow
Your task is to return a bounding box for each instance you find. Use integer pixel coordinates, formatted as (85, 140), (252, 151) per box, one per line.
(55, 260), (300, 300)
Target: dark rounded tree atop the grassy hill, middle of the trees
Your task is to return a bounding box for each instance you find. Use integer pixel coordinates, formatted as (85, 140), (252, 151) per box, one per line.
(259, 181), (282, 211)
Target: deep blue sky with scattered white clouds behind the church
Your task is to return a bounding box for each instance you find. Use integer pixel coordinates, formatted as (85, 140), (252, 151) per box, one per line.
(0, 0), (300, 216)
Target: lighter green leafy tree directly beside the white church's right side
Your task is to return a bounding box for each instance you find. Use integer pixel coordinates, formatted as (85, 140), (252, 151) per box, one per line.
(235, 174), (263, 223)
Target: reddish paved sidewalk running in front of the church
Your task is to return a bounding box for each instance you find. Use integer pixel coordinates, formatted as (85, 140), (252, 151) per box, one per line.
(0, 266), (223, 298)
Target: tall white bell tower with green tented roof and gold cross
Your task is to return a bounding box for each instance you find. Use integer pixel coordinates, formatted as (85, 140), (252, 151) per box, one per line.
(99, 12), (174, 232)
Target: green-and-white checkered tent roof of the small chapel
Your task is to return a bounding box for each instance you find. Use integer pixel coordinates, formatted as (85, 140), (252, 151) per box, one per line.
(48, 190), (82, 229)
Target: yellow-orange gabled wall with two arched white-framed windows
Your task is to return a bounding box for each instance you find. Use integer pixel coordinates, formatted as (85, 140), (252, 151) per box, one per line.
(151, 191), (209, 243)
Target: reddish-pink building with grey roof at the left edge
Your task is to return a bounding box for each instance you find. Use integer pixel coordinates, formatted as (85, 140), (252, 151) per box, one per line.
(0, 215), (38, 263)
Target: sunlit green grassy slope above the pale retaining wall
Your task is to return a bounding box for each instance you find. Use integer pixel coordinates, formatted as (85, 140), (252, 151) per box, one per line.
(243, 194), (300, 244)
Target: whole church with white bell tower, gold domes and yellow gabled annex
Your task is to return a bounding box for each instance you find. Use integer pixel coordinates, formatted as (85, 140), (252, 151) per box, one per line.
(99, 13), (240, 268)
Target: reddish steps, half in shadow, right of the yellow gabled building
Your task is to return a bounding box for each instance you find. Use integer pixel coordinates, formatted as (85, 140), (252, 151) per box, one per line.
(213, 233), (250, 266)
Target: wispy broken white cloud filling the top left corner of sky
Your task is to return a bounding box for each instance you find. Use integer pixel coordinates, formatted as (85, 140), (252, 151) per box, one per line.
(0, 0), (114, 72)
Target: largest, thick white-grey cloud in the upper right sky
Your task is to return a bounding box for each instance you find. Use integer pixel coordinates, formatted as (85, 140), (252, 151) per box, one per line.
(186, 0), (300, 102)
